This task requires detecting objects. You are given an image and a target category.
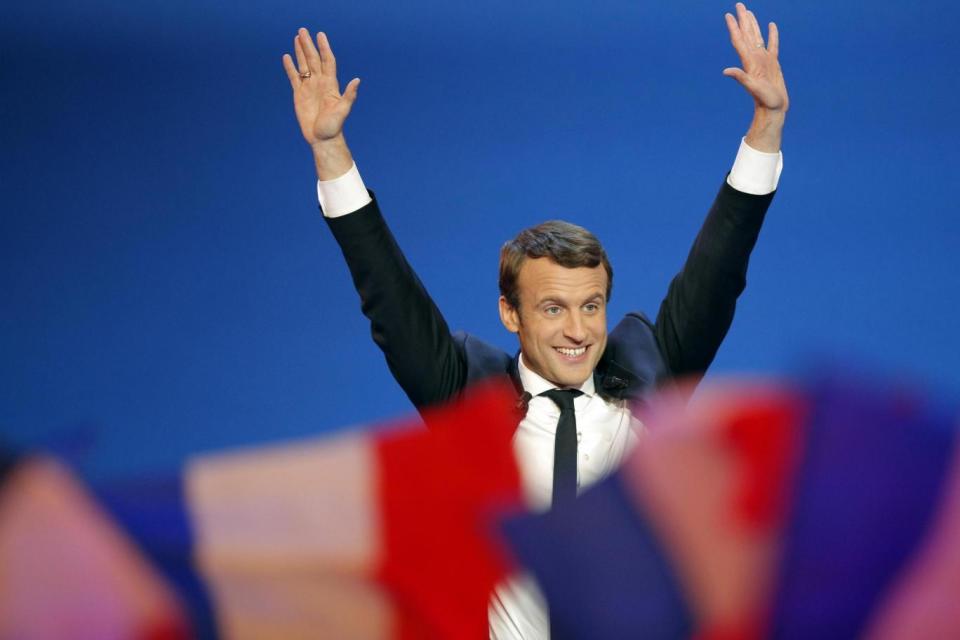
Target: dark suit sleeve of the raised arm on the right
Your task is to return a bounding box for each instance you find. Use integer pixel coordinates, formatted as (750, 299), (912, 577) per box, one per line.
(654, 181), (774, 377)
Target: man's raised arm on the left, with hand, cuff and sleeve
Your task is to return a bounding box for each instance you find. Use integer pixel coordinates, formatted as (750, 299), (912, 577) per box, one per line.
(283, 29), (466, 408)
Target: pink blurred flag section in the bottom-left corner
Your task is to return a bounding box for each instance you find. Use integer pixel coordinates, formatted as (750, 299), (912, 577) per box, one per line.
(0, 459), (189, 640)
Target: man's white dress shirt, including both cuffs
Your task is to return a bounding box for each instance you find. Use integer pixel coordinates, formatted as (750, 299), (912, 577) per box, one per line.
(317, 140), (783, 640)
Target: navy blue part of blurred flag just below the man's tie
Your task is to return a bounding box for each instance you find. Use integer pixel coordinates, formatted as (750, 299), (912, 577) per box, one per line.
(503, 476), (692, 639)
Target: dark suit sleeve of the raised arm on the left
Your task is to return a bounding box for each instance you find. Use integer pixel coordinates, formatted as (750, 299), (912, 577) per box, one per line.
(325, 193), (466, 409)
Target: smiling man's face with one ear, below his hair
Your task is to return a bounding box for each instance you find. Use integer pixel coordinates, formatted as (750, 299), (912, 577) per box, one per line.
(500, 258), (607, 387)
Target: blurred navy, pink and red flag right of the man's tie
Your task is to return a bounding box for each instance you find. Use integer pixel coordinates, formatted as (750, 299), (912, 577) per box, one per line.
(505, 385), (804, 638)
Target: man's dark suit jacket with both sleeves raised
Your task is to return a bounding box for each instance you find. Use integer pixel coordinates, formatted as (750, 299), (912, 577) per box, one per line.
(326, 181), (773, 409)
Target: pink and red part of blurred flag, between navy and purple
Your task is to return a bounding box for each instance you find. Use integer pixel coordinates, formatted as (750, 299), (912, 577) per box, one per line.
(624, 382), (805, 640)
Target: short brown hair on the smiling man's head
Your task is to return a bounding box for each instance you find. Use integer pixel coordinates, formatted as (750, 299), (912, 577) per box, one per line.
(500, 220), (613, 309)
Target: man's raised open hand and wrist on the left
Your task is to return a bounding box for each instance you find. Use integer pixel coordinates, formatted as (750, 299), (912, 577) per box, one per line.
(283, 28), (360, 180)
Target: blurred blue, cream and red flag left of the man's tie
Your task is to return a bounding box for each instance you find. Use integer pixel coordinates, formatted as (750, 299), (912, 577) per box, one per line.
(100, 386), (520, 640)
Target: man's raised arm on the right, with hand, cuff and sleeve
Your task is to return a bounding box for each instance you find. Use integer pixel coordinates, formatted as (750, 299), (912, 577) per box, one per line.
(654, 3), (790, 377)
